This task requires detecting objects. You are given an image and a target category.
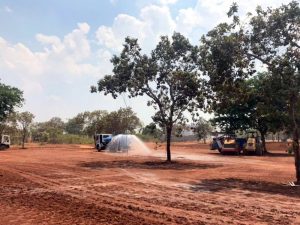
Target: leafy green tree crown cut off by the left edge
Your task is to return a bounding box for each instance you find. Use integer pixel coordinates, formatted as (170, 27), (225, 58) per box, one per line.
(0, 83), (24, 123)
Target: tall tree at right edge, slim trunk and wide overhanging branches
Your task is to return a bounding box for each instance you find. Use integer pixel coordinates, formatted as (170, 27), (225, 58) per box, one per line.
(200, 1), (300, 184)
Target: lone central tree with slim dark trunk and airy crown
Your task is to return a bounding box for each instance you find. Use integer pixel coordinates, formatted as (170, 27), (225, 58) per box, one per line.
(91, 33), (203, 161)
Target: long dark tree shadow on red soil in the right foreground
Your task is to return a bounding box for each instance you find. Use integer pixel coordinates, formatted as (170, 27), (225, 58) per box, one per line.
(190, 178), (300, 198)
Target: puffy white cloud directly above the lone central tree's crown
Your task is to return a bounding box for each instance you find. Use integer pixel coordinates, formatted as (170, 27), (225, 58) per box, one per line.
(96, 5), (176, 52)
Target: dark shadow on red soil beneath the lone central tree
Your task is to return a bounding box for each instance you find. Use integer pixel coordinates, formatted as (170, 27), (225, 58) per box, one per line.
(80, 160), (222, 170)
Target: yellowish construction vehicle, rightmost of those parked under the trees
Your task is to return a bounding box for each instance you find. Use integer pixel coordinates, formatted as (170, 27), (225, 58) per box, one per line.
(244, 131), (264, 156)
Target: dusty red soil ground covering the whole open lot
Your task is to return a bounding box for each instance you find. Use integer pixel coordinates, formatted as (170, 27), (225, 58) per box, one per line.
(0, 143), (300, 225)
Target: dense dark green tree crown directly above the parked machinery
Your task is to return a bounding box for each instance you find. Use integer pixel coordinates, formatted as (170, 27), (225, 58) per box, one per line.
(212, 73), (287, 134)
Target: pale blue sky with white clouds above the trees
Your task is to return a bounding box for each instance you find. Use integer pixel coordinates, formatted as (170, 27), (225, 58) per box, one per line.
(0, 0), (289, 124)
